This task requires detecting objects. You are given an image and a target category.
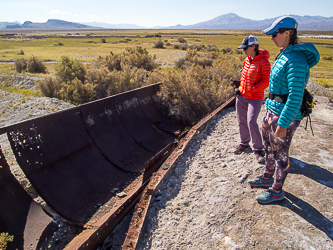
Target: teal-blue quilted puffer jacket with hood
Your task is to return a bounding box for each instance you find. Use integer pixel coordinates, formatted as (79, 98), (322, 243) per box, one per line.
(266, 43), (320, 128)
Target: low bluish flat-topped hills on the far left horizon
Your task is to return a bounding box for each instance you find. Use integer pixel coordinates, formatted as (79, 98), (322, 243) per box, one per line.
(0, 19), (96, 30)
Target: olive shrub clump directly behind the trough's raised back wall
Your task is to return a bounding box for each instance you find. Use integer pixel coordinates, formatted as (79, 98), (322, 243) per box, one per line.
(37, 47), (157, 104)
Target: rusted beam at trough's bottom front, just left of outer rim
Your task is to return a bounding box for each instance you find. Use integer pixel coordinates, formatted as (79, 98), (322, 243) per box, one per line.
(64, 181), (148, 250)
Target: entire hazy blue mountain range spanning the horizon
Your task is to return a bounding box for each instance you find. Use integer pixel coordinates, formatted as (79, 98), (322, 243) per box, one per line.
(0, 13), (333, 31)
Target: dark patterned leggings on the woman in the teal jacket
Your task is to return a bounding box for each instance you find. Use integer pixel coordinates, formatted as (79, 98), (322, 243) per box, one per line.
(262, 112), (300, 191)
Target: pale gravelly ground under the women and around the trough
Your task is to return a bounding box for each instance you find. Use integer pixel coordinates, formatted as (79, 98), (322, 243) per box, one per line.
(0, 75), (333, 250)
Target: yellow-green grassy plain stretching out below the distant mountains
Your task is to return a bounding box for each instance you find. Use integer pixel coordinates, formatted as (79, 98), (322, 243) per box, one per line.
(0, 30), (333, 88)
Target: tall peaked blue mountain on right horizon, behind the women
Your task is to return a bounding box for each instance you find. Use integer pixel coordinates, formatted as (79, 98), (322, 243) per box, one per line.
(165, 13), (333, 30)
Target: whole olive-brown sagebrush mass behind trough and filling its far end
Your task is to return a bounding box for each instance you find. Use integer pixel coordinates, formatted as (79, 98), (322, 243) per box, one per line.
(38, 47), (244, 125)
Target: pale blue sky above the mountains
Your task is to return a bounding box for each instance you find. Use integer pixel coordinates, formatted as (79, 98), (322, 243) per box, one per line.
(0, 0), (333, 28)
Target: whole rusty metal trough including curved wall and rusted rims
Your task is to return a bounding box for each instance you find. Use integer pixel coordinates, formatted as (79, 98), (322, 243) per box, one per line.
(0, 83), (234, 250)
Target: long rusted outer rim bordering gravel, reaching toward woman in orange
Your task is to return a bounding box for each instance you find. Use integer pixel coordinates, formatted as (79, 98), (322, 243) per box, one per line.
(122, 96), (235, 250)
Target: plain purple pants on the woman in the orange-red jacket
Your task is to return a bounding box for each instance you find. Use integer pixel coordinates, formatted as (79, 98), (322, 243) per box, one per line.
(236, 95), (263, 150)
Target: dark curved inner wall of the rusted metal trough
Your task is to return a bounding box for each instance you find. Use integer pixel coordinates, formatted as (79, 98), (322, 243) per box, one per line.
(0, 84), (181, 249)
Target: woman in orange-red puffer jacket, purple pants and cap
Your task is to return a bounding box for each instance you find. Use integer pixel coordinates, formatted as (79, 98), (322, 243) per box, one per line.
(234, 35), (271, 163)
